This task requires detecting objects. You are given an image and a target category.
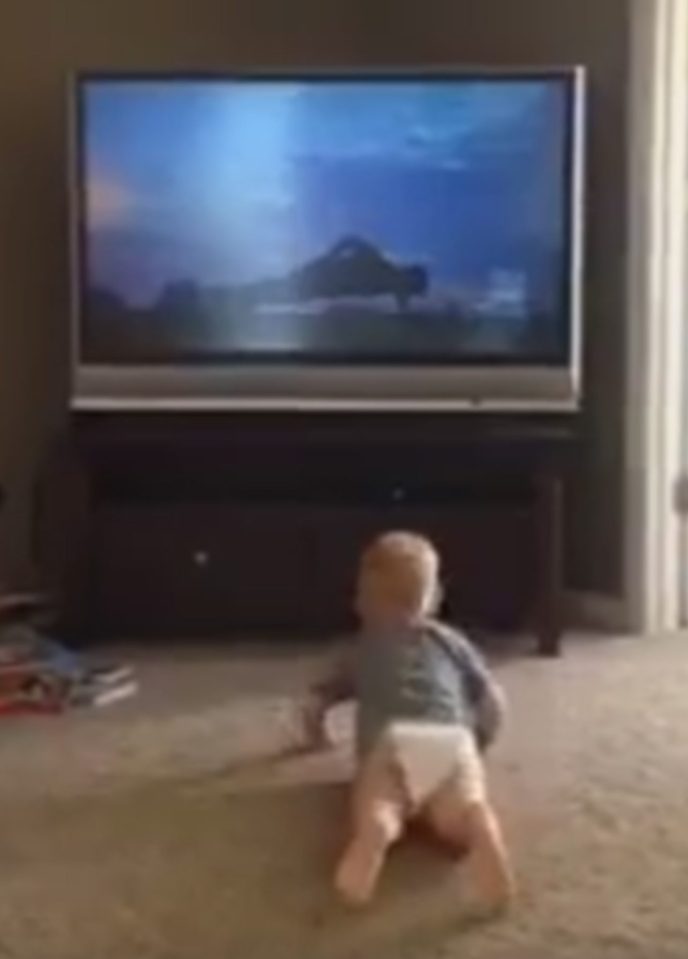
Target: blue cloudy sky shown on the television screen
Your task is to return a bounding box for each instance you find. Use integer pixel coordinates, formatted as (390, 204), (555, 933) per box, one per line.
(84, 80), (566, 303)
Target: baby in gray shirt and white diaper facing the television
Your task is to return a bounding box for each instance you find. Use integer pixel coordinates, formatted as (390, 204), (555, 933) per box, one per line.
(304, 532), (513, 912)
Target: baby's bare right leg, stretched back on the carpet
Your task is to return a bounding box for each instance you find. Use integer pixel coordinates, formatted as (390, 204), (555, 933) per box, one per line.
(424, 783), (514, 909)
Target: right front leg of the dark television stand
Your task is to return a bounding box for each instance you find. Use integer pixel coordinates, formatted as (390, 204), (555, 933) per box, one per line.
(536, 472), (564, 658)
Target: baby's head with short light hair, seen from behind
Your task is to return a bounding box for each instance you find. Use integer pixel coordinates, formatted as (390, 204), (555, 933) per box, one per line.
(356, 532), (440, 625)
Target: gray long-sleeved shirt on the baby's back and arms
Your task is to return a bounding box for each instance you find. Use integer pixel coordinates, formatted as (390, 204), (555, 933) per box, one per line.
(316, 620), (503, 755)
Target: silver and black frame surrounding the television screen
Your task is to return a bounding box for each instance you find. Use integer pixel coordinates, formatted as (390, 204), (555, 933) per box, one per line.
(68, 66), (587, 413)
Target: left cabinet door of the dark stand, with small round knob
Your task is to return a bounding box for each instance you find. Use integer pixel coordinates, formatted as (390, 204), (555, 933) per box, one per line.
(94, 504), (304, 635)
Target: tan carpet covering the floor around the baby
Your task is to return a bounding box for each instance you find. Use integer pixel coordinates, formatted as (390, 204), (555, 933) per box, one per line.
(0, 638), (688, 959)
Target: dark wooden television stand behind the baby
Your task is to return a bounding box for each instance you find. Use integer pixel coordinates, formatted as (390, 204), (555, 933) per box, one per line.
(38, 413), (574, 655)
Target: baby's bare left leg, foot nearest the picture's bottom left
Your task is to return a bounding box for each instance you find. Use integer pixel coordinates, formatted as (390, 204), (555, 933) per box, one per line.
(335, 751), (404, 906)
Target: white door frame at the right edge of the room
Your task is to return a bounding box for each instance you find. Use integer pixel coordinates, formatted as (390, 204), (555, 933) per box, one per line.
(623, 0), (688, 632)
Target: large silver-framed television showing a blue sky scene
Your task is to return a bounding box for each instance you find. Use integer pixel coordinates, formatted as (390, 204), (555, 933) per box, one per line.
(71, 68), (585, 410)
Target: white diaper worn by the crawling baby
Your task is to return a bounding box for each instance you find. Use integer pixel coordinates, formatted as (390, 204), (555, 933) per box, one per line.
(383, 721), (485, 808)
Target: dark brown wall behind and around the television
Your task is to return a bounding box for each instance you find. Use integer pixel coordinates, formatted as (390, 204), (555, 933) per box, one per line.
(0, 0), (628, 592)
